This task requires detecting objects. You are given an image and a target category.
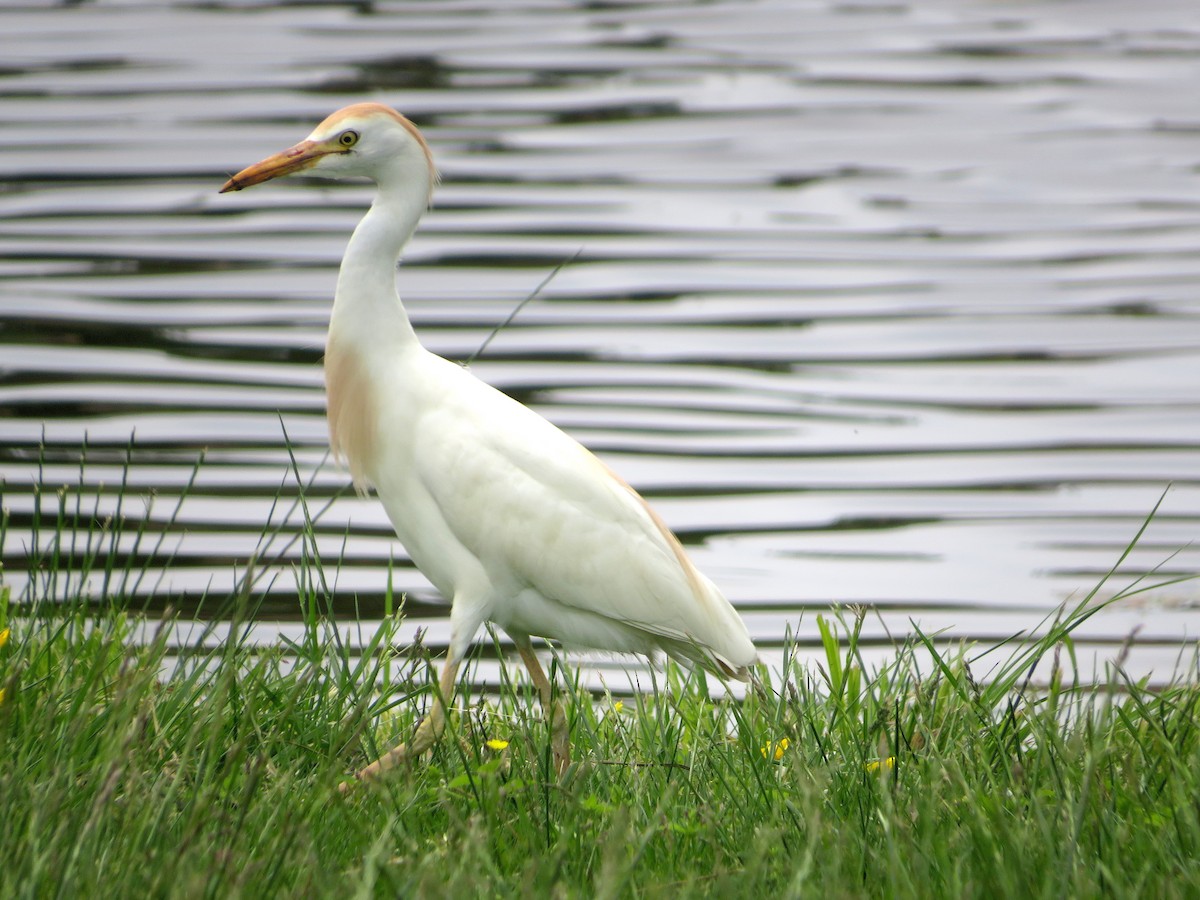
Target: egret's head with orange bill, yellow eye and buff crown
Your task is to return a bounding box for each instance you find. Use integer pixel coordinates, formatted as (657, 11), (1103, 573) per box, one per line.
(221, 103), (437, 193)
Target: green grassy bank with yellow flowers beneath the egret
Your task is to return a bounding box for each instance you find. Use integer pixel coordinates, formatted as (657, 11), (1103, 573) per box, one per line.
(0, 465), (1200, 898)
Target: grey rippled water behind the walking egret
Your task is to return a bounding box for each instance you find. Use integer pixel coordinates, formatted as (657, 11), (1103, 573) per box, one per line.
(0, 0), (1200, 676)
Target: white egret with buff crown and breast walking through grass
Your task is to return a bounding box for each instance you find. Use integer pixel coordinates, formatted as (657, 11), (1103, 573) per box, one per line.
(221, 103), (757, 780)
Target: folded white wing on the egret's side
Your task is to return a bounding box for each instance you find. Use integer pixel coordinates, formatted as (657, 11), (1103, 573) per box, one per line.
(415, 364), (756, 670)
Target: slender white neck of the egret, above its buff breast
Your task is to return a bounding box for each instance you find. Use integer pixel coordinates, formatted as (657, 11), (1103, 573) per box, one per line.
(329, 174), (428, 349)
